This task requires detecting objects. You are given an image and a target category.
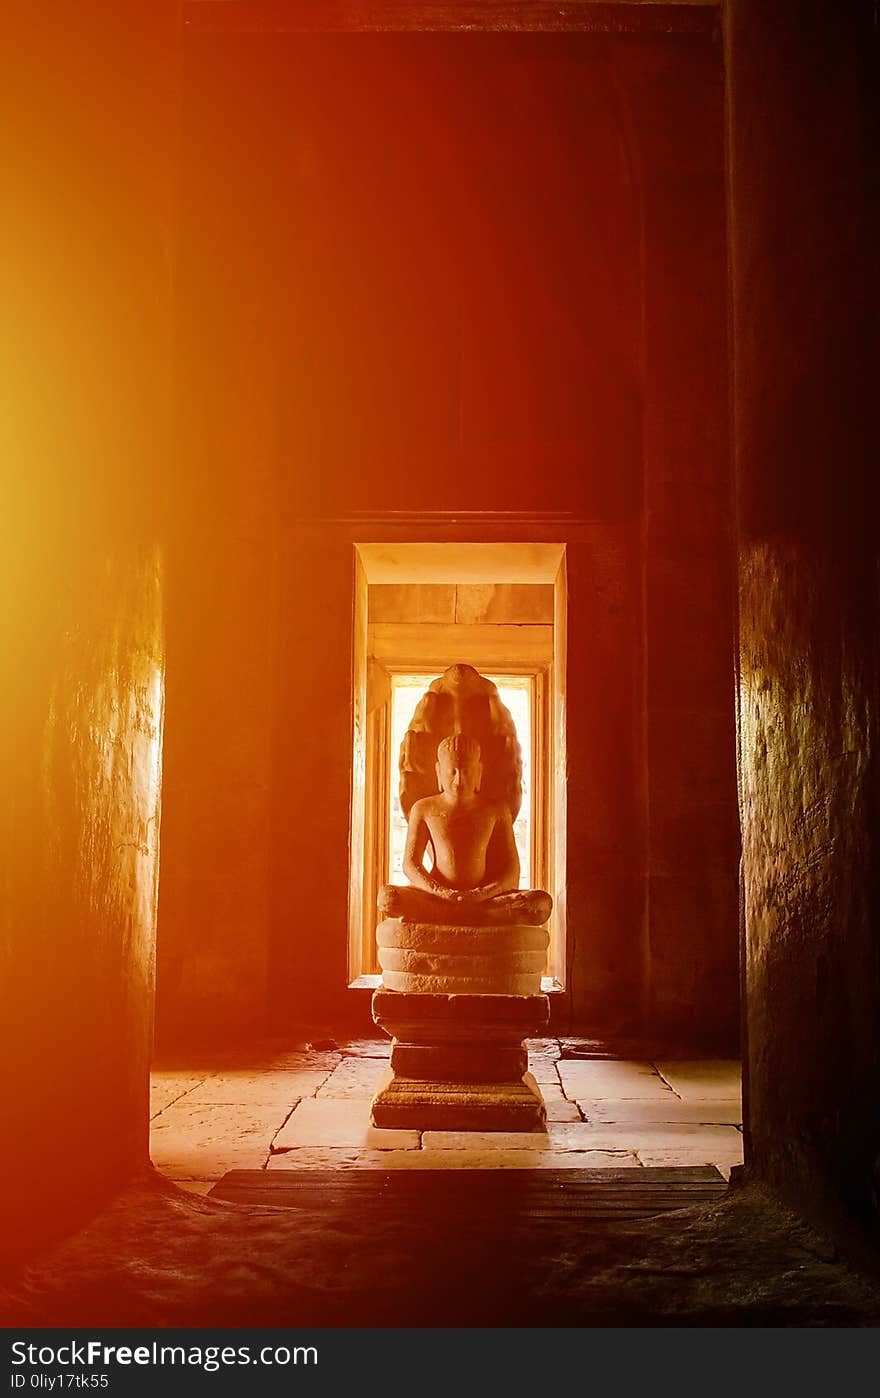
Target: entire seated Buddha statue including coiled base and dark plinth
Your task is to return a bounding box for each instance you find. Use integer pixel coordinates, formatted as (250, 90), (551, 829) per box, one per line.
(371, 665), (553, 1131)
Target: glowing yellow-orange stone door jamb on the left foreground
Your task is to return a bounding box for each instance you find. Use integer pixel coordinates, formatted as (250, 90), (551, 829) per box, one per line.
(0, 3), (175, 1251)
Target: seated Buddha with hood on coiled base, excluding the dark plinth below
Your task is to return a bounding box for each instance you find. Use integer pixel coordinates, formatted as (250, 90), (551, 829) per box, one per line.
(376, 665), (553, 995)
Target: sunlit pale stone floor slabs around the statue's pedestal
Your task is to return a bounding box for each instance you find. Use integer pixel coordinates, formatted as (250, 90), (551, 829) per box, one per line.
(151, 1039), (743, 1194)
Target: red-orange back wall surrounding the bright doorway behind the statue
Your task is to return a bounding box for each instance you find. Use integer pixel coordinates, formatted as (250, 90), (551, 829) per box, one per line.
(158, 32), (737, 1044)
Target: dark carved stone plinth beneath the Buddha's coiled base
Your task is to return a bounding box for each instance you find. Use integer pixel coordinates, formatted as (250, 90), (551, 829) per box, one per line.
(372, 989), (550, 1131)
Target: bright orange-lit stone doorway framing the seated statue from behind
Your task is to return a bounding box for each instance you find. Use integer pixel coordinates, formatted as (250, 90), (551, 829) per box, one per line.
(348, 540), (567, 991)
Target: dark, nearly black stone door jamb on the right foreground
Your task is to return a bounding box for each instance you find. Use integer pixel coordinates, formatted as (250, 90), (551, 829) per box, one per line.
(726, 0), (880, 1241)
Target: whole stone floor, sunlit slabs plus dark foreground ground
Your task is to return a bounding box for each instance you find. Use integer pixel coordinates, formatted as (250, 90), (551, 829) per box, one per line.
(6, 1036), (880, 1325)
